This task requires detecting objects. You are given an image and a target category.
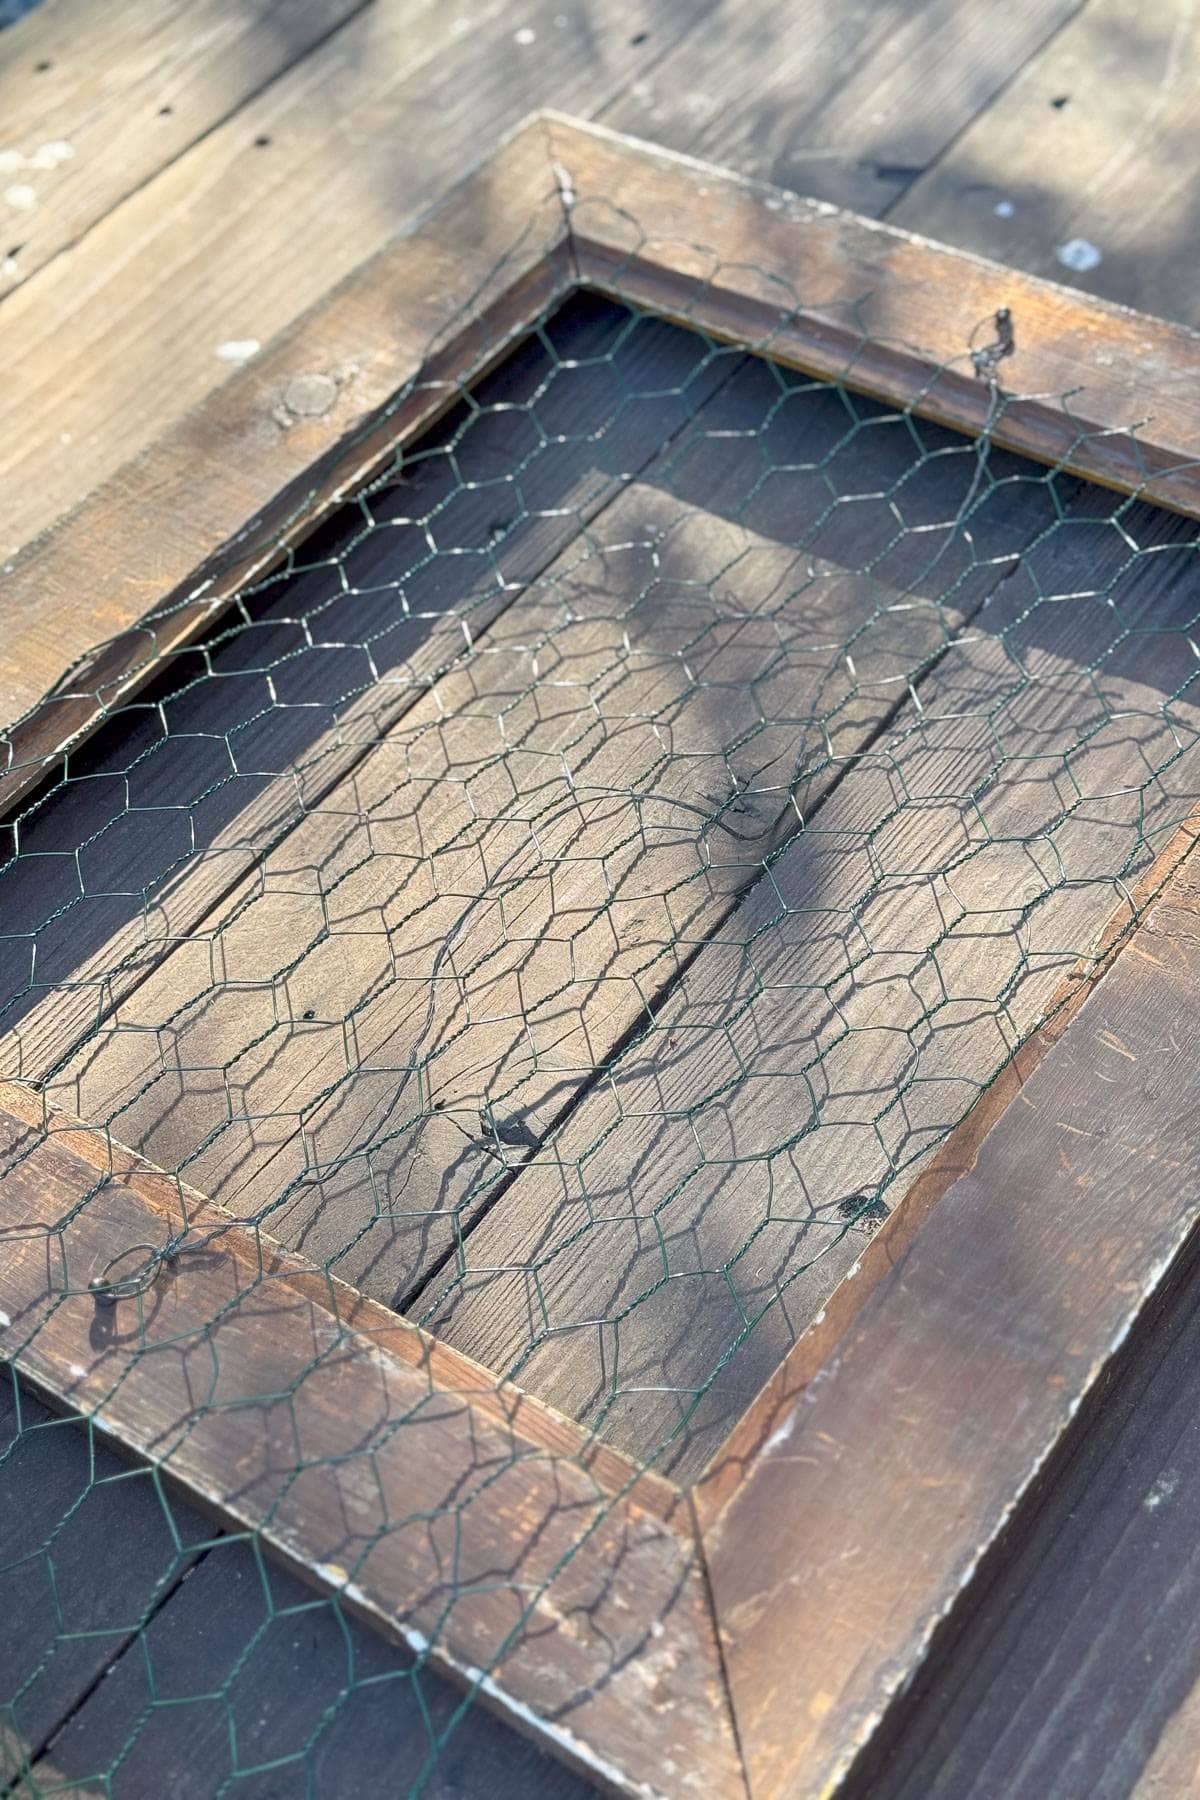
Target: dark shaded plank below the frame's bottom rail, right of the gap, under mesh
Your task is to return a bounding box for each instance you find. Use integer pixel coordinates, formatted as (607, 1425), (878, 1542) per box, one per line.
(28, 1526), (596, 1800)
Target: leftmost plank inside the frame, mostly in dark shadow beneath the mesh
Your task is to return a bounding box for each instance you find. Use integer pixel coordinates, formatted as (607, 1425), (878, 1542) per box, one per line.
(0, 295), (738, 1080)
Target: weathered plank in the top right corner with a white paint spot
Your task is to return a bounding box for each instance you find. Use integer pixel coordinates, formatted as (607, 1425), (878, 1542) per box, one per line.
(892, 0), (1200, 326)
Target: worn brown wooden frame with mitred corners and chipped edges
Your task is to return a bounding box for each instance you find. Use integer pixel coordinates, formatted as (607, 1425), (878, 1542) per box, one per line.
(0, 115), (1200, 1800)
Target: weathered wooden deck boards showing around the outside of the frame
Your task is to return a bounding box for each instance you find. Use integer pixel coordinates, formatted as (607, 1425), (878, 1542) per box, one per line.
(0, 0), (1200, 1800)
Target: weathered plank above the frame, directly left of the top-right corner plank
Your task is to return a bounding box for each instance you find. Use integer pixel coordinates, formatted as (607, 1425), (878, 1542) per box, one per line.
(596, 0), (1079, 216)
